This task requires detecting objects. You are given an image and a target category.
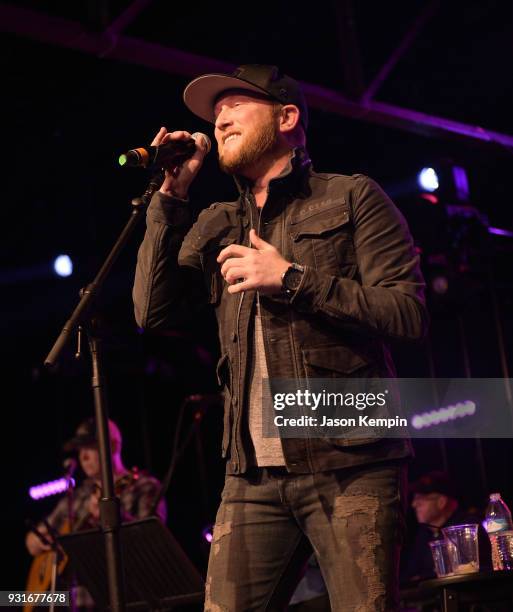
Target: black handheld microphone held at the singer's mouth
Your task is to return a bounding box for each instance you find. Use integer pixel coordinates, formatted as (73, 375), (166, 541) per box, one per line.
(118, 132), (212, 168)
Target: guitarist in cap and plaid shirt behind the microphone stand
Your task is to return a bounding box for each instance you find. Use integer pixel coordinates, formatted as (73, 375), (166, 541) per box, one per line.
(25, 418), (166, 608)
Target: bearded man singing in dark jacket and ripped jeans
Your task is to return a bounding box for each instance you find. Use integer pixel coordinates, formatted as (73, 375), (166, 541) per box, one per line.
(133, 64), (427, 612)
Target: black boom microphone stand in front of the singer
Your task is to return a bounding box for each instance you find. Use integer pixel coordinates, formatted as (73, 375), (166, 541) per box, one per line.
(44, 171), (164, 612)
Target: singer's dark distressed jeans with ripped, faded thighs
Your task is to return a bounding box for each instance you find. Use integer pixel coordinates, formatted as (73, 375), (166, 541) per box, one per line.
(205, 461), (406, 612)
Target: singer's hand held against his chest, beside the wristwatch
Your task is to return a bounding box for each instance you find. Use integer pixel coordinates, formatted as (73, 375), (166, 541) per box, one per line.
(217, 229), (290, 295)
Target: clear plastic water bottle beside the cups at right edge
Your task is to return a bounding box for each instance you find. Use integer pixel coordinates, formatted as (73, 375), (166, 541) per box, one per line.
(483, 493), (513, 570)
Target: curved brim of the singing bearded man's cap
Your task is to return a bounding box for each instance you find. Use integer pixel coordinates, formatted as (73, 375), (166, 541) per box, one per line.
(183, 74), (270, 123)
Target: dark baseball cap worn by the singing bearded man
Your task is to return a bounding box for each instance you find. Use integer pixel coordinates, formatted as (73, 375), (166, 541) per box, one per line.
(183, 64), (308, 130)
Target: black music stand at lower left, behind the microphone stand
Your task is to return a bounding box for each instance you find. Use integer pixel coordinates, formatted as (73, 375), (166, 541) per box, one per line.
(58, 517), (204, 611)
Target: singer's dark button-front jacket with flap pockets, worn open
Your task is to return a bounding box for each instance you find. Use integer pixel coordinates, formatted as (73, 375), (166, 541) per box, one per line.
(133, 149), (427, 474)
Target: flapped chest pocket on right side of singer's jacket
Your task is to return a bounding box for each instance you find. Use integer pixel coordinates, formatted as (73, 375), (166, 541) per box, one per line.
(289, 201), (356, 278)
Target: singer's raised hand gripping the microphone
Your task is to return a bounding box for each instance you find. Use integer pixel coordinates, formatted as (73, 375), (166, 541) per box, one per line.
(151, 127), (208, 199)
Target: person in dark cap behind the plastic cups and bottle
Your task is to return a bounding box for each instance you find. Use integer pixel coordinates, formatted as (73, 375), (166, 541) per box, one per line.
(401, 470), (491, 584)
